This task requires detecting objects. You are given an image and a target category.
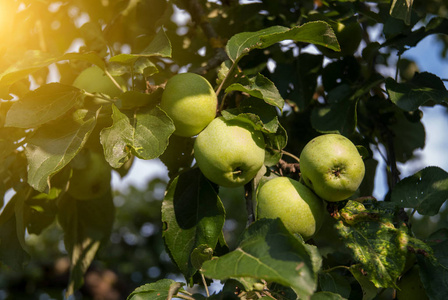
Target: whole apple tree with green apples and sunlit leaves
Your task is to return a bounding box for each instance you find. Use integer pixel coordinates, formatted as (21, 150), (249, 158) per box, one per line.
(0, 0), (448, 300)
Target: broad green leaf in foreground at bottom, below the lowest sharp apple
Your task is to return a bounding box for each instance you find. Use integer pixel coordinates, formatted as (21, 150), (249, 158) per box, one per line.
(202, 219), (321, 298)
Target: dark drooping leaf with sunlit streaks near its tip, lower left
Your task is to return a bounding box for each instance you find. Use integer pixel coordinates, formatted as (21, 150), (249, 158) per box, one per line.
(58, 191), (115, 297)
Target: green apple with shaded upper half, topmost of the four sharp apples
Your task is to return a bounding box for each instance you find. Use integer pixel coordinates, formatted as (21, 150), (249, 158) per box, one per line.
(160, 73), (218, 137)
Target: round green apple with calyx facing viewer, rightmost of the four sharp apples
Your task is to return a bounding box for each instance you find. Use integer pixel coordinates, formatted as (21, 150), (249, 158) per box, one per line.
(300, 134), (365, 201)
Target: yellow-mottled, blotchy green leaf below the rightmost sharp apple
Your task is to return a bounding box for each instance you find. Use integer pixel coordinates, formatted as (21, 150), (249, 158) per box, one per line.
(336, 200), (409, 288)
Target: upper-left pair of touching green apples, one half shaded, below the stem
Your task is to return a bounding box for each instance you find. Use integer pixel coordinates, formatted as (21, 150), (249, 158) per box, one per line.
(160, 73), (265, 187)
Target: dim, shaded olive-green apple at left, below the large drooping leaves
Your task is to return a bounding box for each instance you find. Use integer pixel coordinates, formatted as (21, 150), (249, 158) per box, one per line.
(67, 151), (111, 200)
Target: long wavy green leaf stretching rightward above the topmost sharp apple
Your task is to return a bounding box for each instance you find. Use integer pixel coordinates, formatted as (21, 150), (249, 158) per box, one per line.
(226, 21), (340, 62)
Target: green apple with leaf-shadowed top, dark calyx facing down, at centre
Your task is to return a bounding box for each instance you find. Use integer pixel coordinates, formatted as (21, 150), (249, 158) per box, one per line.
(194, 117), (265, 187)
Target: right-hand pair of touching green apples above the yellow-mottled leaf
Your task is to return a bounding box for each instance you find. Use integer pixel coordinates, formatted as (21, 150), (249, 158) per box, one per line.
(257, 134), (365, 240)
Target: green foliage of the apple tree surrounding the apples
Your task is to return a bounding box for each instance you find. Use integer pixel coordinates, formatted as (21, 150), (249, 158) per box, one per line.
(0, 0), (448, 300)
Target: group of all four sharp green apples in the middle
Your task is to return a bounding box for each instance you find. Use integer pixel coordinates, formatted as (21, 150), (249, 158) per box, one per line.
(160, 73), (365, 240)
